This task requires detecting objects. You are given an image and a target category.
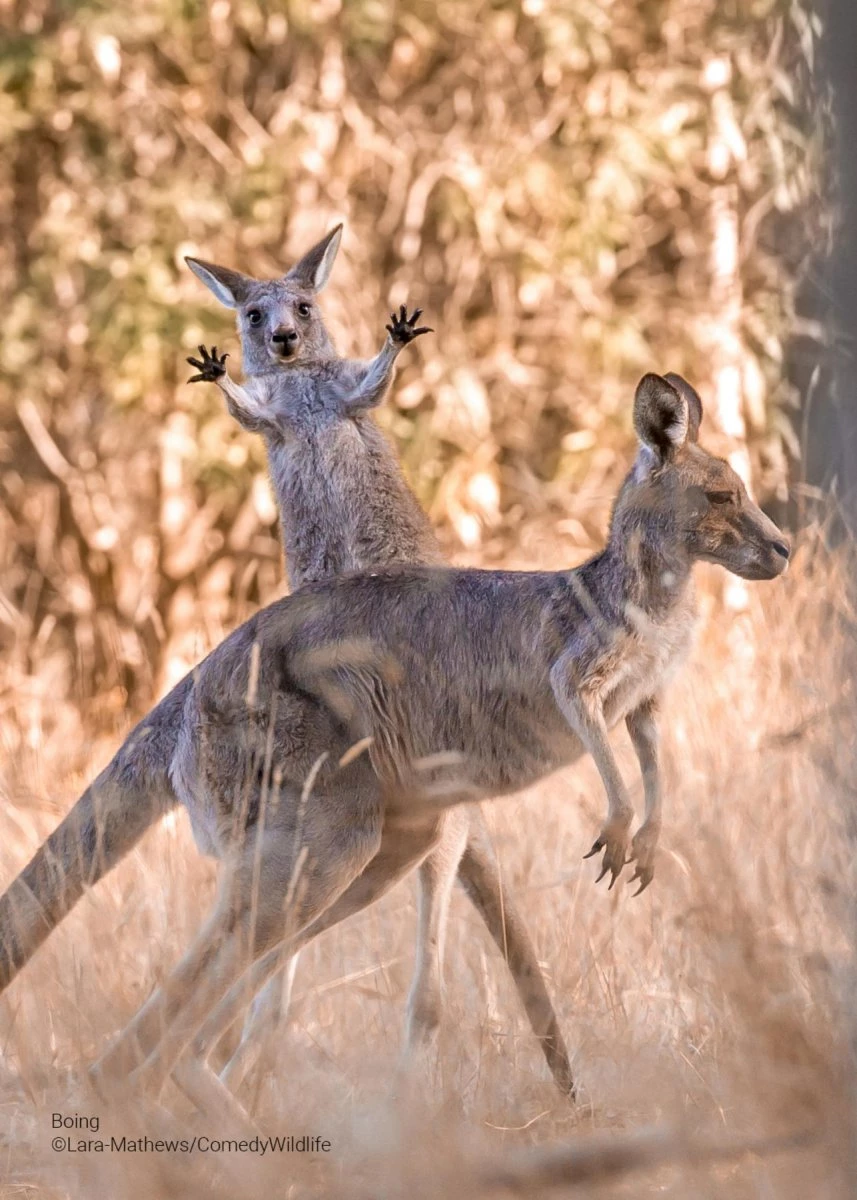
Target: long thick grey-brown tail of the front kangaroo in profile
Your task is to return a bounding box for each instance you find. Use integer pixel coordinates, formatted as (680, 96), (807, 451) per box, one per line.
(0, 689), (187, 991)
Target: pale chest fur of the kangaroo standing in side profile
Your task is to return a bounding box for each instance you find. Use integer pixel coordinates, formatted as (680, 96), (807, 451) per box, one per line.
(585, 588), (696, 726)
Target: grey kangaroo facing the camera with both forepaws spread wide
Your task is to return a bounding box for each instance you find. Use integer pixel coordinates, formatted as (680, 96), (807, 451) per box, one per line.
(180, 226), (571, 1092)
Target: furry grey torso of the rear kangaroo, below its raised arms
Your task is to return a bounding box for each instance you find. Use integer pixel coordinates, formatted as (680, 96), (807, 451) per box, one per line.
(268, 415), (442, 588)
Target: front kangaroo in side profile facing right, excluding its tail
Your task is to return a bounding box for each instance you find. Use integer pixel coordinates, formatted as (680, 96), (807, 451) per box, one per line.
(66, 374), (790, 1093)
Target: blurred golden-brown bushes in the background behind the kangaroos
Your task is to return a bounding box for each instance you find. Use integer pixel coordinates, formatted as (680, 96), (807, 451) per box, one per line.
(0, 0), (827, 752)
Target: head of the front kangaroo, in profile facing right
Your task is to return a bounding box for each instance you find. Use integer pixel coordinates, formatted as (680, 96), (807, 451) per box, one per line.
(611, 374), (790, 580)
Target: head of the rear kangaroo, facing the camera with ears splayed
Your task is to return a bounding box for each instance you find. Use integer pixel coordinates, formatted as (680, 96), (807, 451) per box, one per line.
(185, 224), (342, 376)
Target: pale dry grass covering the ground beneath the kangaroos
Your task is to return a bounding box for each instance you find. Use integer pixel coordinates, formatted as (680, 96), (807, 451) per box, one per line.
(0, 520), (857, 1200)
